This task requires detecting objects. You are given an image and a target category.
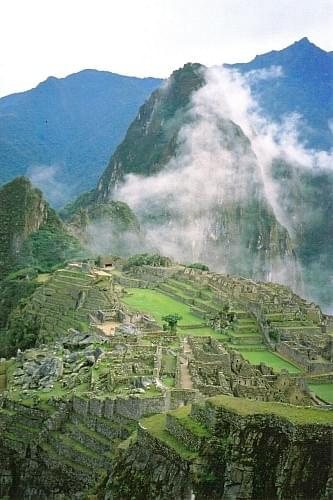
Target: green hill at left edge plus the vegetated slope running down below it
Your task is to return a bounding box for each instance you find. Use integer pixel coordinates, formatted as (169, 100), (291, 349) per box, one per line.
(0, 177), (86, 356)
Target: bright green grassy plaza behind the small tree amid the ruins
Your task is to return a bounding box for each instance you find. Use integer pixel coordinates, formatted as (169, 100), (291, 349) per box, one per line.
(122, 288), (222, 338)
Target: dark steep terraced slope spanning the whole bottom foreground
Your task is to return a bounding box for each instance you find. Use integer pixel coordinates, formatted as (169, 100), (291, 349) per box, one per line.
(0, 382), (333, 500)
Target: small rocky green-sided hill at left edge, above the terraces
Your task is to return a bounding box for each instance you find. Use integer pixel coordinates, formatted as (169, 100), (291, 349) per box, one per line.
(0, 177), (81, 277)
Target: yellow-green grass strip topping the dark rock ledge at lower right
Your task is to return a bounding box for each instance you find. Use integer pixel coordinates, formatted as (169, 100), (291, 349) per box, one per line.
(207, 395), (333, 426)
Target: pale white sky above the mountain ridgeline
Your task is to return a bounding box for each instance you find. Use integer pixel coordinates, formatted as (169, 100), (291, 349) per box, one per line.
(0, 0), (333, 96)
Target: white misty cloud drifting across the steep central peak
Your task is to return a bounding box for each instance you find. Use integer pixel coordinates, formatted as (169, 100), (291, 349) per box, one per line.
(114, 67), (333, 308)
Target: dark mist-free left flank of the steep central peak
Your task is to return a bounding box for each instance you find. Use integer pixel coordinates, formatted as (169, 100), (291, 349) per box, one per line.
(95, 64), (204, 199)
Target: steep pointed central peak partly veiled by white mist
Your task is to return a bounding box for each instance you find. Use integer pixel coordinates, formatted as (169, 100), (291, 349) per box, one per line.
(94, 64), (297, 284)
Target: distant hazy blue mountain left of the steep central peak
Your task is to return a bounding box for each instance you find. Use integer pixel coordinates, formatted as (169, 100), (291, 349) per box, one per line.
(0, 70), (161, 206)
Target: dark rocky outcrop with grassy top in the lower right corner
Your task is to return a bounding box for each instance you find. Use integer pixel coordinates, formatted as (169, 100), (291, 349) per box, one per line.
(106, 396), (333, 500)
